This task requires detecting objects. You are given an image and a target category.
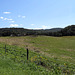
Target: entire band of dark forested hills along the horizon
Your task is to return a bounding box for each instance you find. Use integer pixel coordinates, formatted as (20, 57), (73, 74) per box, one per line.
(0, 25), (75, 36)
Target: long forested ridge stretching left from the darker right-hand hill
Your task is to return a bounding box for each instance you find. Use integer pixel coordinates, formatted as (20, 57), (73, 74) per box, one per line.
(0, 28), (61, 36)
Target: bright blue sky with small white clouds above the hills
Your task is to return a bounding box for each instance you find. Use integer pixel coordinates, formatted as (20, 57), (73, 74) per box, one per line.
(0, 0), (75, 29)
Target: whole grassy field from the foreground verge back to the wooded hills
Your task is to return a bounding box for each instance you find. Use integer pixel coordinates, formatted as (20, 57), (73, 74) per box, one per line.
(0, 36), (75, 75)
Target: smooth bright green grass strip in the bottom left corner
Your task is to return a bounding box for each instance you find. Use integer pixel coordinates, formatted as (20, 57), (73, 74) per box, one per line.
(0, 58), (49, 75)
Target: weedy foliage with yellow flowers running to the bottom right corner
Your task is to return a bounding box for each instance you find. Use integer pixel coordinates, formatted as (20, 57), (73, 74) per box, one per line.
(31, 56), (75, 75)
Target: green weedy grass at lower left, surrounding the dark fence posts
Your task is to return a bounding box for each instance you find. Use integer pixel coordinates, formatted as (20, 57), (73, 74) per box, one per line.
(0, 44), (49, 75)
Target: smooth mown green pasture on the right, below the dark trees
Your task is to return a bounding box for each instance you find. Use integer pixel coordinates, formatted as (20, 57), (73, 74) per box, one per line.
(29, 36), (75, 63)
